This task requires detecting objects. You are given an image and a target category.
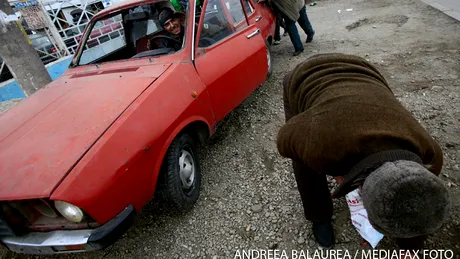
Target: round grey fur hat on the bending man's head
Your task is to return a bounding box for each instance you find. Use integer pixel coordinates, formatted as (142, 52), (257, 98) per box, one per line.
(362, 160), (450, 238)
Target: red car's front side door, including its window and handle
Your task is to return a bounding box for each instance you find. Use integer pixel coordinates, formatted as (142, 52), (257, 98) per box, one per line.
(194, 0), (268, 124)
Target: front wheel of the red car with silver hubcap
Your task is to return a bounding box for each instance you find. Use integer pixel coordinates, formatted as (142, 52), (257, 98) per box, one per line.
(160, 133), (201, 213)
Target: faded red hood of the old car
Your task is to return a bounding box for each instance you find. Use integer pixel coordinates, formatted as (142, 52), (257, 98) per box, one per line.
(0, 64), (170, 200)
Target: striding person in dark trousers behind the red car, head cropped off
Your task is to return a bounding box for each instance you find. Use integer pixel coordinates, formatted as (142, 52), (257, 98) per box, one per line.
(269, 0), (315, 56)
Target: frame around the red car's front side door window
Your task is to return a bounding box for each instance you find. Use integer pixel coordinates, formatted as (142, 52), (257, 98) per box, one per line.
(194, 0), (251, 51)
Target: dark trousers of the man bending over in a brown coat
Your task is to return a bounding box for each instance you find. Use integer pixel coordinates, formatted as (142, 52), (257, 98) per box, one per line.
(283, 78), (332, 221)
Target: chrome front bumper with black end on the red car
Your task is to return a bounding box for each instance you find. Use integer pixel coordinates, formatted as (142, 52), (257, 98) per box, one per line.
(0, 205), (137, 254)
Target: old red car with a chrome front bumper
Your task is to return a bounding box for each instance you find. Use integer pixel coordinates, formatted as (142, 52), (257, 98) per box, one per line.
(0, 0), (275, 254)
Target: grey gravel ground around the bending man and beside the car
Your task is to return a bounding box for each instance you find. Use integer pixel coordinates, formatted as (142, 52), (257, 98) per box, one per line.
(0, 0), (460, 259)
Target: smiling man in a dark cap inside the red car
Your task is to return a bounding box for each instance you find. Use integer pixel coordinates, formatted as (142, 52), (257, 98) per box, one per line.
(147, 7), (185, 51)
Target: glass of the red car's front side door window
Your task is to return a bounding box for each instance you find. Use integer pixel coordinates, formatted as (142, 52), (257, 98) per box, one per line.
(198, 0), (247, 48)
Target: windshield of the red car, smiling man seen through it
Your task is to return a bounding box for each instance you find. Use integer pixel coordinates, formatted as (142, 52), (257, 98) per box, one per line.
(74, 1), (193, 65)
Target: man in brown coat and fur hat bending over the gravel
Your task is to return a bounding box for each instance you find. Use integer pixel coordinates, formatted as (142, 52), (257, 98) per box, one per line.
(277, 54), (450, 250)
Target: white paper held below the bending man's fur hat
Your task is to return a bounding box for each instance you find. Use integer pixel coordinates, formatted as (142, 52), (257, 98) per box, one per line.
(345, 189), (383, 248)
